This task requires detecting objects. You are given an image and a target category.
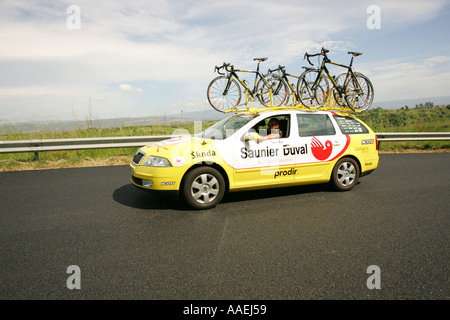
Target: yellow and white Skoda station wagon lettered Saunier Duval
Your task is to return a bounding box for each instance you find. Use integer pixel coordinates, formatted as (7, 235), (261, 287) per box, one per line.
(130, 108), (379, 209)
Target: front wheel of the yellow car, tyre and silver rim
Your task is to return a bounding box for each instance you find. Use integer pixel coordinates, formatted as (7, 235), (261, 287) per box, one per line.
(182, 167), (225, 209)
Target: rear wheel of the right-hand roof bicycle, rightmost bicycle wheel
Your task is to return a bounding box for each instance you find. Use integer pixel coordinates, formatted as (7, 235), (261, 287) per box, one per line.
(345, 72), (374, 111)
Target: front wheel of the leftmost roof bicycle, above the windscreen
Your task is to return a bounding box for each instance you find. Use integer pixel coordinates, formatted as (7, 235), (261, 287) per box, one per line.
(207, 76), (241, 112)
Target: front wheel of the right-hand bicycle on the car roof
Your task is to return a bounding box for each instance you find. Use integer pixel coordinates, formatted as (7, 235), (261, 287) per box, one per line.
(297, 70), (328, 108)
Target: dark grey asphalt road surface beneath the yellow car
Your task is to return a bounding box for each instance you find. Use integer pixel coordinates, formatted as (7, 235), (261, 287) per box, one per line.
(0, 153), (450, 300)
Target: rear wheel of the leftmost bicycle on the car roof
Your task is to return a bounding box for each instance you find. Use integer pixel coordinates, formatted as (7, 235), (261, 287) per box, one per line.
(256, 73), (288, 107)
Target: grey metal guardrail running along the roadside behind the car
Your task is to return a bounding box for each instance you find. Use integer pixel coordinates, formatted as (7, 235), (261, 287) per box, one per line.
(0, 132), (450, 160)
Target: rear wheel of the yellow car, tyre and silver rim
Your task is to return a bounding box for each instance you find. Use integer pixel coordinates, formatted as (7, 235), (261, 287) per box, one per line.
(331, 158), (360, 191)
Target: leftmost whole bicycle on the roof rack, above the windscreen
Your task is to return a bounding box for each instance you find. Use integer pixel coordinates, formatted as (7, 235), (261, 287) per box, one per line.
(207, 58), (287, 112)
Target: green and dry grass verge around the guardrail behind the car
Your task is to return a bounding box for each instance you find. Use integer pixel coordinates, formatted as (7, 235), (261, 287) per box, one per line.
(0, 105), (450, 172)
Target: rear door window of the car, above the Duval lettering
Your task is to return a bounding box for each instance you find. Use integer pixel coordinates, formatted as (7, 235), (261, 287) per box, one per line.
(297, 114), (336, 137)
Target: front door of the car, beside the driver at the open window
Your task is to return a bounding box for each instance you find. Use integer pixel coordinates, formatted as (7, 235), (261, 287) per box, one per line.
(233, 113), (295, 187)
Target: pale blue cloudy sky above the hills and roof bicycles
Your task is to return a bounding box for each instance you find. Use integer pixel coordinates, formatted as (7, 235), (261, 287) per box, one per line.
(0, 0), (450, 122)
